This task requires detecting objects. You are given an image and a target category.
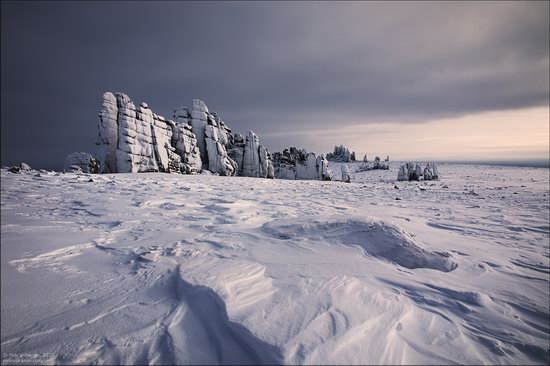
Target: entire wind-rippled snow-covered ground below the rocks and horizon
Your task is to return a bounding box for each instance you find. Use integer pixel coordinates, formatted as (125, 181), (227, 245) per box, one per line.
(1, 162), (550, 364)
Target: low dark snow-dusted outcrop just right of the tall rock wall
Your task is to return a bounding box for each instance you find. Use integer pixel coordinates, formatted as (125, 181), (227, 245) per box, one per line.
(273, 147), (333, 180)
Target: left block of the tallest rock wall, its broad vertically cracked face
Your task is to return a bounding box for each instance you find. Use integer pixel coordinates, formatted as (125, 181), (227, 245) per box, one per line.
(97, 92), (205, 173)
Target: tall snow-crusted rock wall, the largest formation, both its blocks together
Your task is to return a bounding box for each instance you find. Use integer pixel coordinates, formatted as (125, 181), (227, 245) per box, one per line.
(97, 92), (274, 178)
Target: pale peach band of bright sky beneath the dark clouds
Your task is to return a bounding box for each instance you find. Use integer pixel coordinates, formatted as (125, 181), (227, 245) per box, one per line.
(265, 107), (550, 161)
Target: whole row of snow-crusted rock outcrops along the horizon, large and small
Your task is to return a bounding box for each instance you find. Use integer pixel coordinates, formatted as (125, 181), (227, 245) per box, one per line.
(64, 92), (437, 181)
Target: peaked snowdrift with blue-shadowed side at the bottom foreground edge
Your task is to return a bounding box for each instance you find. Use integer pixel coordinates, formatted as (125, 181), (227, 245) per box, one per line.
(138, 265), (282, 365)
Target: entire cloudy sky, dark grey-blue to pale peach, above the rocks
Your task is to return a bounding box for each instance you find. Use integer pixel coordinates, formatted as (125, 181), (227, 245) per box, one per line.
(0, 1), (550, 169)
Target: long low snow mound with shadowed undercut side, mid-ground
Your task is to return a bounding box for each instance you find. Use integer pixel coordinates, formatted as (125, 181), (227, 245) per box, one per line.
(263, 218), (458, 272)
